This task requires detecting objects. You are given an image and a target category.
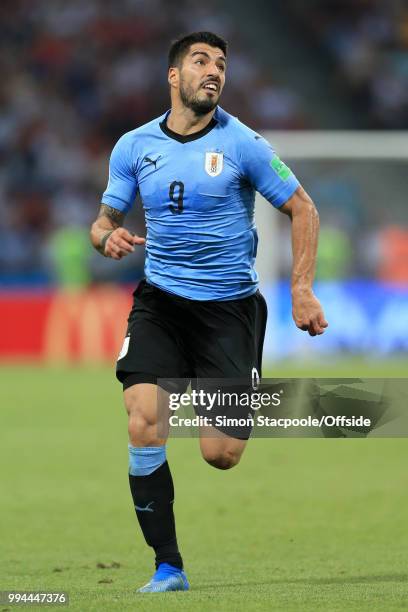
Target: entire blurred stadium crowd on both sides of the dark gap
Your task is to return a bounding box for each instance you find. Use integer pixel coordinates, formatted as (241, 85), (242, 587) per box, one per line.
(0, 0), (408, 286)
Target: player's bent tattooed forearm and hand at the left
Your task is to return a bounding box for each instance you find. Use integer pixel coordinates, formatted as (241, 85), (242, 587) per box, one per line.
(91, 204), (145, 259)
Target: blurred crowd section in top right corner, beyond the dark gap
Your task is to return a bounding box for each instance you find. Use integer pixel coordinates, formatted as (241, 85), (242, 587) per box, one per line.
(286, 0), (408, 129)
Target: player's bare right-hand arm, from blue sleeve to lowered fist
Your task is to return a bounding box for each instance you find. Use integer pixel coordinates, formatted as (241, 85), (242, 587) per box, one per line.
(280, 187), (328, 336)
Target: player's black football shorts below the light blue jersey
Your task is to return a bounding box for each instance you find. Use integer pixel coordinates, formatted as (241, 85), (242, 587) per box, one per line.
(116, 280), (267, 437)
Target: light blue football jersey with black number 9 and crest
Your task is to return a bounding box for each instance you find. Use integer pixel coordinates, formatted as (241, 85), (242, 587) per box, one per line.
(102, 107), (299, 300)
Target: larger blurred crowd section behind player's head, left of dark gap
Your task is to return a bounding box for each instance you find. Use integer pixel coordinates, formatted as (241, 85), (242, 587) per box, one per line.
(0, 0), (303, 284)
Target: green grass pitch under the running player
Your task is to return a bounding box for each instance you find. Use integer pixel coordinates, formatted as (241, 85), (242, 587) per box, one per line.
(0, 360), (408, 612)
